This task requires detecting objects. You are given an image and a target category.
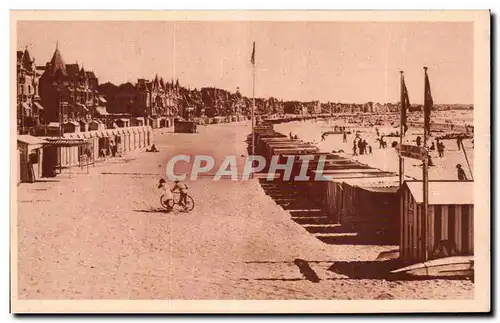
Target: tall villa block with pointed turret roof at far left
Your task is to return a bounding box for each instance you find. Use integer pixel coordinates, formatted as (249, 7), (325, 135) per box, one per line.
(17, 47), (103, 134)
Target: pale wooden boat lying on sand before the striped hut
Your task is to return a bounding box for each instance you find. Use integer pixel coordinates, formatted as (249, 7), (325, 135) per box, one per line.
(391, 256), (474, 277)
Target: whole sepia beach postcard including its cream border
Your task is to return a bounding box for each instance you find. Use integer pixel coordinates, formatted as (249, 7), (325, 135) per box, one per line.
(10, 11), (491, 313)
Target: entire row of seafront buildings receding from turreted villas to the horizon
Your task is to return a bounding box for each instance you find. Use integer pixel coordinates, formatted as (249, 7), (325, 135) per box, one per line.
(17, 46), (473, 134)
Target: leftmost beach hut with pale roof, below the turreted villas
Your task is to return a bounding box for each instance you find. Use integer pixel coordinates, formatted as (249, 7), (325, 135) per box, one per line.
(17, 135), (47, 183)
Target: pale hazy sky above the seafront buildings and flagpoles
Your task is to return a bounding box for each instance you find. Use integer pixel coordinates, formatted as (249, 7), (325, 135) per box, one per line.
(17, 21), (474, 104)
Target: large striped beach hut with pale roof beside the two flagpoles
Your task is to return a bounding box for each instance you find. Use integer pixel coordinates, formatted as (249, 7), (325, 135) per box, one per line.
(400, 181), (474, 262)
